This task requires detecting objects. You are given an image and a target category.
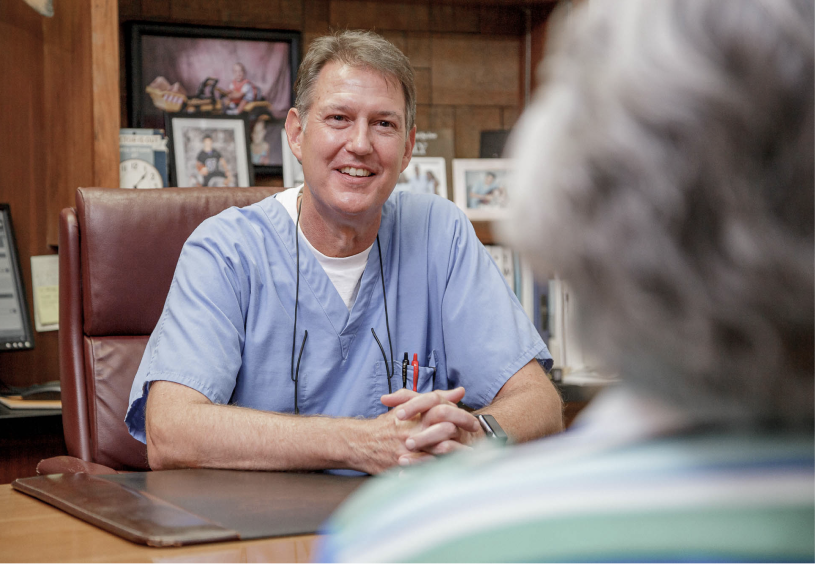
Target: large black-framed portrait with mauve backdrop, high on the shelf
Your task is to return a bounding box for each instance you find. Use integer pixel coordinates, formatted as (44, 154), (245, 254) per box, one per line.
(126, 23), (300, 174)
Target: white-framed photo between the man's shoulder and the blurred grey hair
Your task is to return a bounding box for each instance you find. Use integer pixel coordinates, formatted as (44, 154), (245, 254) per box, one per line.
(453, 159), (513, 221)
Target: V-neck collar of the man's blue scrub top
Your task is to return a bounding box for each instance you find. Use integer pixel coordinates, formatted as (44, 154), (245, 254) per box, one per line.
(269, 199), (394, 340)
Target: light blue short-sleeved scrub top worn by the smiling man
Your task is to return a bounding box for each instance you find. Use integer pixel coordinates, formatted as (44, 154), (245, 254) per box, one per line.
(125, 192), (552, 442)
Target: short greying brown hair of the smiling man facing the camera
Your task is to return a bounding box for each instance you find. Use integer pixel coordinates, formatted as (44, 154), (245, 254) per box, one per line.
(294, 31), (416, 132)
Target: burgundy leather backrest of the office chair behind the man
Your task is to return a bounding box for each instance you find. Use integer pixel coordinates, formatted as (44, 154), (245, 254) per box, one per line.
(59, 187), (281, 470)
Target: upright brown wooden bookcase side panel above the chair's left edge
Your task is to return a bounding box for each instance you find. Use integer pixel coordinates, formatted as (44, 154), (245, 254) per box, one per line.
(43, 0), (120, 246)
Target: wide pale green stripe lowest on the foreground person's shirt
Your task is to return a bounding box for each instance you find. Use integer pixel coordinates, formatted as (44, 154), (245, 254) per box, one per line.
(394, 507), (815, 564)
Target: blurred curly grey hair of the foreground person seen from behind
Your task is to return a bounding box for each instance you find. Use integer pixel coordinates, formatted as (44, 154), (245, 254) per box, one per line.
(508, 0), (815, 423)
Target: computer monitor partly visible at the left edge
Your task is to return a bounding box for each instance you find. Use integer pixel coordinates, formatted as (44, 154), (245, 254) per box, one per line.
(0, 204), (34, 352)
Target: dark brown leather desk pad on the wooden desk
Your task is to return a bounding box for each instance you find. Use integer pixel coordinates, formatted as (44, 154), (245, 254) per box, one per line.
(12, 469), (365, 546)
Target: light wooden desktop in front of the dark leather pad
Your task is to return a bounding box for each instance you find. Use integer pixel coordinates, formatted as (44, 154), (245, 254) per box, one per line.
(0, 484), (317, 564)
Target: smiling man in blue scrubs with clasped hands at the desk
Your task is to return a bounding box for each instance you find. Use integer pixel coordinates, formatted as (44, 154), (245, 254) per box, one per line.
(126, 32), (562, 473)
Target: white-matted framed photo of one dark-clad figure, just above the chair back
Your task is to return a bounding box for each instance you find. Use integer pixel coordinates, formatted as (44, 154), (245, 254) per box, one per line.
(167, 114), (255, 188)
